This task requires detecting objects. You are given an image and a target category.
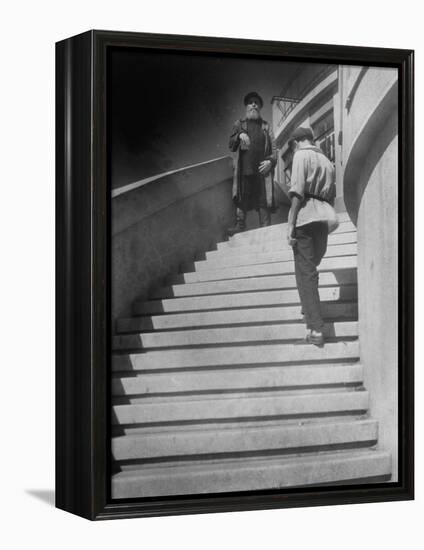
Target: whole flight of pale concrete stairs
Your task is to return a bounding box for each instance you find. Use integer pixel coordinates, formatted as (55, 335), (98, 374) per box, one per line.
(112, 215), (391, 498)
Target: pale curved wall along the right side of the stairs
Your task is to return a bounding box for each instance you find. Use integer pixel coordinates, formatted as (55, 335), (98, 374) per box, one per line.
(343, 68), (398, 481)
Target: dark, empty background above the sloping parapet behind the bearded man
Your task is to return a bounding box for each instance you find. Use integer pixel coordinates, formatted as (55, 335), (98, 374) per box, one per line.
(109, 50), (307, 187)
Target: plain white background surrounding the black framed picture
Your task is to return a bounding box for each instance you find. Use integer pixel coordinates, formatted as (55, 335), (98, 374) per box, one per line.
(0, 0), (424, 550)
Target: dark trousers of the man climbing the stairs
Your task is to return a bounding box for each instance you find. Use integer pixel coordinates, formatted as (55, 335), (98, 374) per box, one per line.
(293, 222), (328, 332)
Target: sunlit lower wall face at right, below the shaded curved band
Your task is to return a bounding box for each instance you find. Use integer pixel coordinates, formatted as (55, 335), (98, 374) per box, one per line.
(358, 119), (398, 481)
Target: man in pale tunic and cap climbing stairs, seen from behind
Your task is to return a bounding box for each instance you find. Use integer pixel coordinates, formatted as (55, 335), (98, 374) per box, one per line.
(287, 128), (338, 346)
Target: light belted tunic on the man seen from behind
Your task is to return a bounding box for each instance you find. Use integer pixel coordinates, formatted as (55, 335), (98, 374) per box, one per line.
(289, 145), (339, 233)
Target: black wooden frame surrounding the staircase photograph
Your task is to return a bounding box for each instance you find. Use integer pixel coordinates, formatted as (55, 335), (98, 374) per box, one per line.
(56, 30), (414, 520)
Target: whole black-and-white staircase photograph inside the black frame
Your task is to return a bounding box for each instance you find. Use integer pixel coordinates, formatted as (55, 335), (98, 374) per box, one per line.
(106, 48), (401, 501)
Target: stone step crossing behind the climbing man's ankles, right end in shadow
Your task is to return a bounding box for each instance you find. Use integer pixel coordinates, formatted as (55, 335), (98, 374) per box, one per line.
(117, 302), (358, 332)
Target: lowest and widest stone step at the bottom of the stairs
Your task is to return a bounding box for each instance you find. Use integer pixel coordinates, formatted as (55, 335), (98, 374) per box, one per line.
(112, 450), (391, 498)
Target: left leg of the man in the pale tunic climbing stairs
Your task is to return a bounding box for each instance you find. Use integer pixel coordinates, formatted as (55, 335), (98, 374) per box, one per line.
(293, 224), (324, 340)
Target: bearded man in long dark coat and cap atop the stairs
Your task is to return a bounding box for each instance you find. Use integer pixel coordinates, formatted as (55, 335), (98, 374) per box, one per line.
(227, 92), (277, 236)
